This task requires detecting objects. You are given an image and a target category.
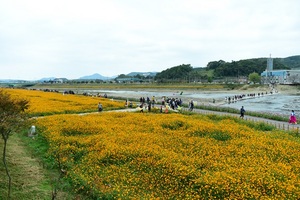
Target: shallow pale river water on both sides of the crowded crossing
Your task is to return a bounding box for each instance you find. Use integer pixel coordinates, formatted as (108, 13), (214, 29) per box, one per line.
(80, 90), (300, 115)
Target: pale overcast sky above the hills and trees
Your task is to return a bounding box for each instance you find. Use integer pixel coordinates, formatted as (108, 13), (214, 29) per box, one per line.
(0, 0), (300, 80)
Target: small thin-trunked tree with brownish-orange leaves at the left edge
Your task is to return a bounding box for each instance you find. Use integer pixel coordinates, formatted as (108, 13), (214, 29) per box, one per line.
(0, 90), (29, 199)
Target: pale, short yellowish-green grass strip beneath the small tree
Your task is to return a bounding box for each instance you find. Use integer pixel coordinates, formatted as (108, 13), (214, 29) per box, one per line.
(0, 132), (73, 200)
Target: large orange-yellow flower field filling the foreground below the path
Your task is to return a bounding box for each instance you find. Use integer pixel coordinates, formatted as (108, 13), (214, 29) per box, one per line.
(36, 111), (300, 199)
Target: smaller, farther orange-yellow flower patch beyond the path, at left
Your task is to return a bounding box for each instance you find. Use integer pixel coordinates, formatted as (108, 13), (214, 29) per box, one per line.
(4, 89), (125, 116)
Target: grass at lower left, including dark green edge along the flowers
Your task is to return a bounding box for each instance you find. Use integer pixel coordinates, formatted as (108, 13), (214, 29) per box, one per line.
(0, 131), (81, 200)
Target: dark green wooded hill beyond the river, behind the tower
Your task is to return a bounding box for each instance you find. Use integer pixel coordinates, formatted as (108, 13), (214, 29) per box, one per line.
(154, 56), (300, 82)
